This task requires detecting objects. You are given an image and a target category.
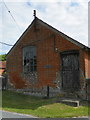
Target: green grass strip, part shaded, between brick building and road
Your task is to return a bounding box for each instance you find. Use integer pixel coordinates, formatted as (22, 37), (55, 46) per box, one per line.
(2, 91), (88, 118)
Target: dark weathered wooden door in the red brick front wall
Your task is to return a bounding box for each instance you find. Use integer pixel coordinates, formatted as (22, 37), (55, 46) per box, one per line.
(61, 51), (80, 91)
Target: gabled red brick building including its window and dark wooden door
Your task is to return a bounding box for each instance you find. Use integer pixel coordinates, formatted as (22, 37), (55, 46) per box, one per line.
(7, 17), (90, 98)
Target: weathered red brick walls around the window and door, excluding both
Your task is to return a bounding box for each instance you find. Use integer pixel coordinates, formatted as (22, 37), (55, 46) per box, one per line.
(7, 18), (90, 98)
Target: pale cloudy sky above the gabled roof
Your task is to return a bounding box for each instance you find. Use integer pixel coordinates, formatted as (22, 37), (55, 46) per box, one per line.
(0, 0), (88, 54)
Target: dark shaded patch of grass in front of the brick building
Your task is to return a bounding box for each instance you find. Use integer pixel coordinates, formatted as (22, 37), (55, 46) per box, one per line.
(2, 91), (54, 110)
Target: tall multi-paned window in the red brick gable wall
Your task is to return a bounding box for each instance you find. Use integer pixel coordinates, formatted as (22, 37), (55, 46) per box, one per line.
(23, 46), (37, 73)
